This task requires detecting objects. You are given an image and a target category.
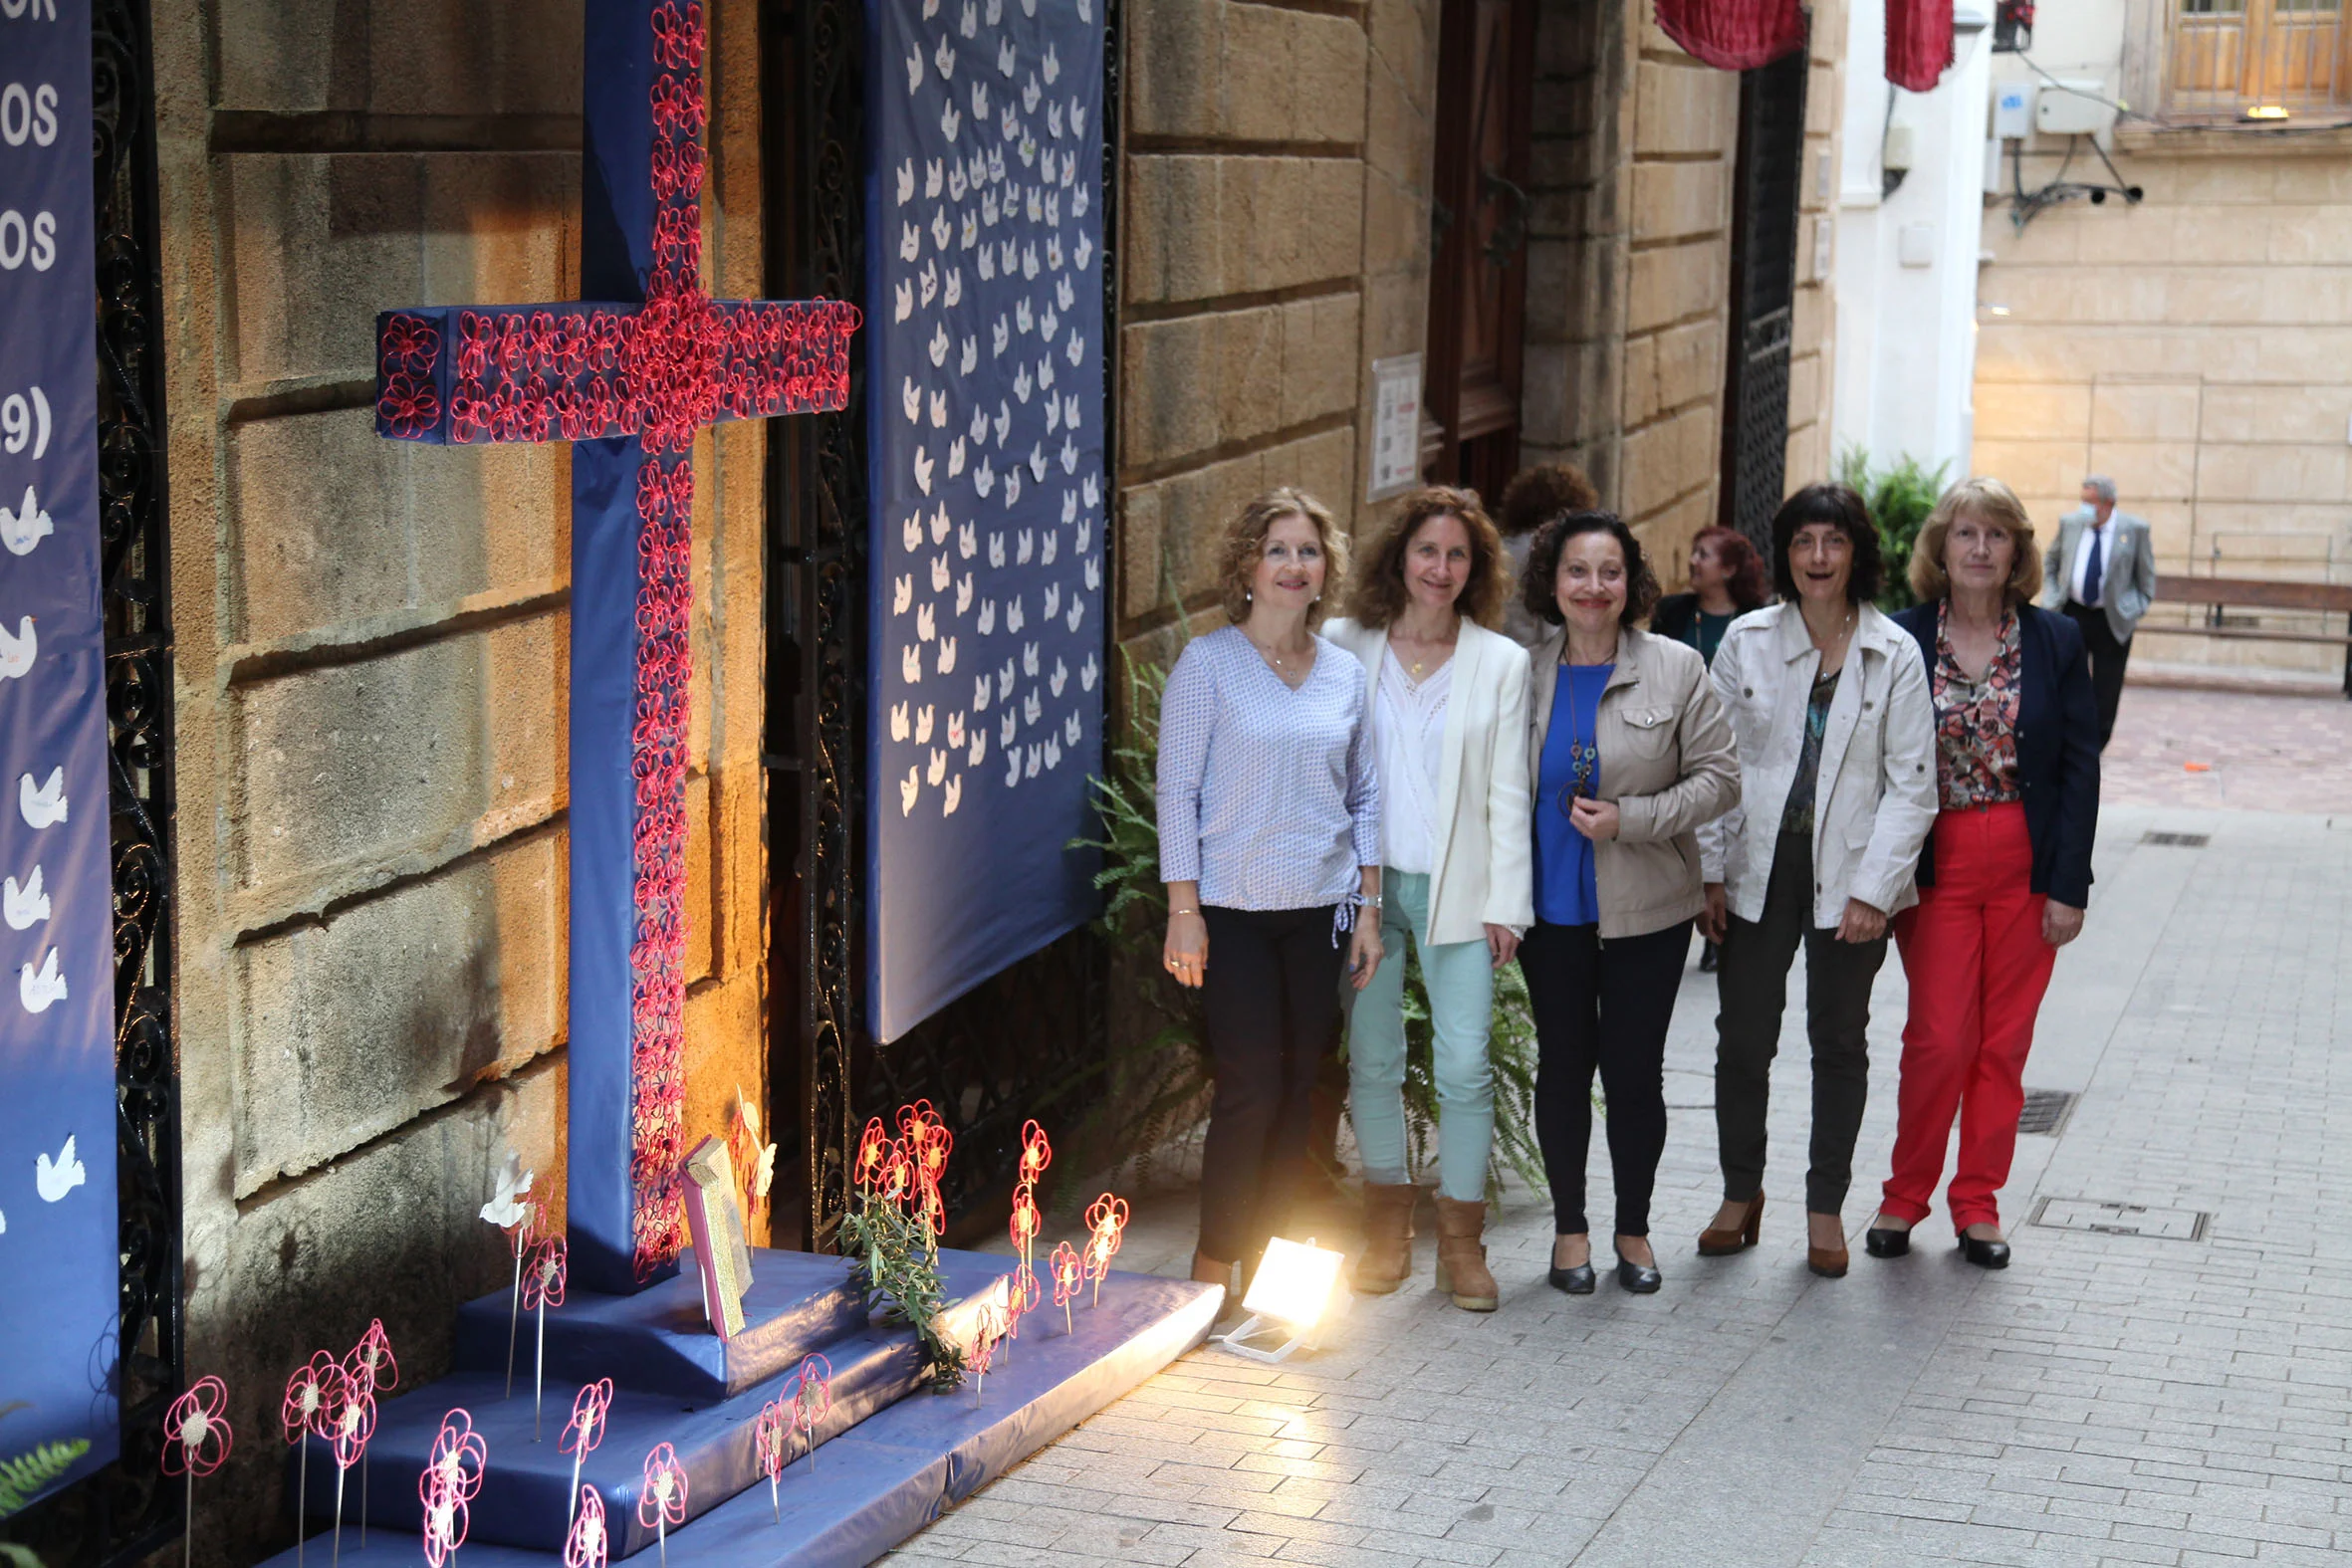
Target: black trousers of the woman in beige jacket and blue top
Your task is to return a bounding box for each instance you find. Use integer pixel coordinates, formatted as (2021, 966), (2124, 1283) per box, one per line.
(1520, 922), (1691, 1236)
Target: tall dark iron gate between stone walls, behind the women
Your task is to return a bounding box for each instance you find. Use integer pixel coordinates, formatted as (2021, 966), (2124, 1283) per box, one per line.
(1720, 50), (1808, 555)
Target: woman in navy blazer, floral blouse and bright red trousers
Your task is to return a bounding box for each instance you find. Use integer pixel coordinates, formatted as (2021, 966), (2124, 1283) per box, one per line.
(1863, 480), (2098, 1269)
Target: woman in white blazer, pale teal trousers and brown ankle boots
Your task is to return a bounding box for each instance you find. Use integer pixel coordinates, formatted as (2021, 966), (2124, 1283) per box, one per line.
(1321, 489), (1535, 1312)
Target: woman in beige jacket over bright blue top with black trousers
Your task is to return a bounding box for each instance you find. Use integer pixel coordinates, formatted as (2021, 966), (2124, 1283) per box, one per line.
(1520, 513), (1739, 1295)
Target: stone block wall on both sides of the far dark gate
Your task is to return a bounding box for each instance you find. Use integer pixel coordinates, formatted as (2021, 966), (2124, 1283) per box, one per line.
(1522, 0), (1844, 580)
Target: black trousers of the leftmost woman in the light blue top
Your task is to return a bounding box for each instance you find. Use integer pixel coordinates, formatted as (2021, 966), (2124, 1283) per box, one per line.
(1200, 905), (1347, 1262)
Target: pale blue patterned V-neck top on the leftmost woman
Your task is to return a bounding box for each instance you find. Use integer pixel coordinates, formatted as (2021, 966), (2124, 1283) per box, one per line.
(1159, 625), (1380, 910)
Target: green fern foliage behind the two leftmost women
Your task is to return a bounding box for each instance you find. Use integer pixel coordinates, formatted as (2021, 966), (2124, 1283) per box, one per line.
(1072, 653), (1542, 1197)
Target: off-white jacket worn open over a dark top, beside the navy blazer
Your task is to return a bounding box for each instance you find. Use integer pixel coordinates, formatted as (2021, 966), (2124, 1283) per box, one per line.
(1701, 604), (1936, 926)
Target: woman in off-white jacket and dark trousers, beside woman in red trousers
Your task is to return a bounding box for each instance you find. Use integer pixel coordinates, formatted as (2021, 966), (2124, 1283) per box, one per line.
(1698, 484), (1936, 1279)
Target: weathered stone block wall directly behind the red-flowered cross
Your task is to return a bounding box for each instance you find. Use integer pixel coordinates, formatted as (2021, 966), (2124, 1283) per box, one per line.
(155, 0), (765, 1561)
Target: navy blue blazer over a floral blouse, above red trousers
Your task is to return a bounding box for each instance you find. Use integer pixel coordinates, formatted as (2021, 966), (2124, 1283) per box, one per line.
(1893, 604), (2098, 910)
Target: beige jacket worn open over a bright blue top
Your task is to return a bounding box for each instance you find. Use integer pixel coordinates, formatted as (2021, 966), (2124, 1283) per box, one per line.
(1527, 627), (1741, 941)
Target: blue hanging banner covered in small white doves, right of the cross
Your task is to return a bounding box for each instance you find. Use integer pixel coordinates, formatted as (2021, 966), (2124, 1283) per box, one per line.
(865, 0), (1110, 1041)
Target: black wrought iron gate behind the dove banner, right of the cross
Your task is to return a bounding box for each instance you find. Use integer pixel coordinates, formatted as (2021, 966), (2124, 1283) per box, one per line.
(760, 0), (1119, 1248)
